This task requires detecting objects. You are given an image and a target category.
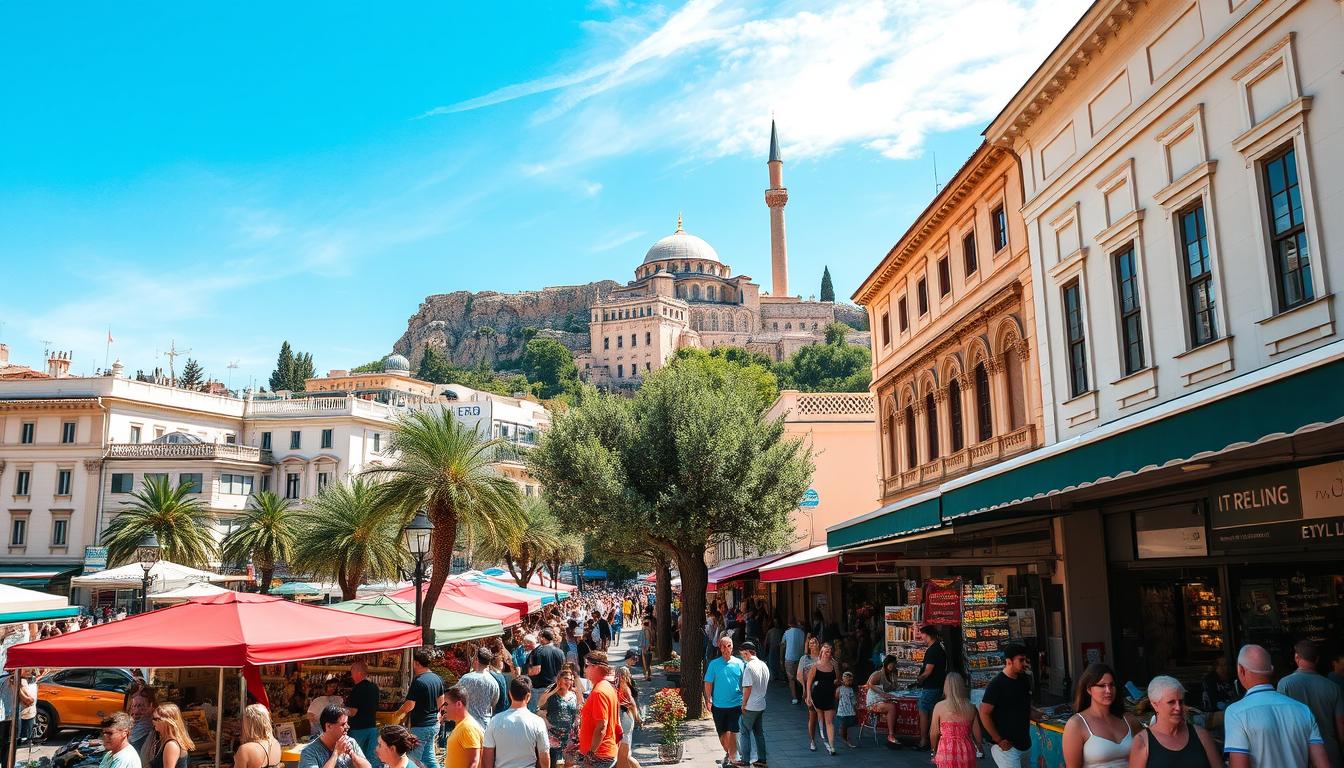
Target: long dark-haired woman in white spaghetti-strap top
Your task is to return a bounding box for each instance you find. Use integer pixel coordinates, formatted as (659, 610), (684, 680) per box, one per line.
(1064, 664), (1141, 768)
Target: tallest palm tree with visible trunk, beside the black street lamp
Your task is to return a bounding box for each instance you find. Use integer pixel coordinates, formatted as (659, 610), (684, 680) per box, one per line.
(366, 409), (523, 643)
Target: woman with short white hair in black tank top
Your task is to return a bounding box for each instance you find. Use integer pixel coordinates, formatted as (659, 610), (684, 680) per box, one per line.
(1128, 677), (1223, 768)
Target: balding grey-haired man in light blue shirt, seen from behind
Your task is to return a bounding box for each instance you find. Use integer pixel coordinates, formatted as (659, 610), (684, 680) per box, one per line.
(1223, 646), (1329, 768)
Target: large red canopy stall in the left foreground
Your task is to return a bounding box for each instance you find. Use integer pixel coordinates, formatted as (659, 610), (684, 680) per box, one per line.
(5, 592), (421, 767)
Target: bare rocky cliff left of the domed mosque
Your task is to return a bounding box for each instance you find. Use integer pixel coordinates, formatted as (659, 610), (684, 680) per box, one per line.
(392, 280), (620, 370)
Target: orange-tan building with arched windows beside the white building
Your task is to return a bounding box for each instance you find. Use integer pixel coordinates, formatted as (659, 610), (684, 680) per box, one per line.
(853, 144), (1042, 504)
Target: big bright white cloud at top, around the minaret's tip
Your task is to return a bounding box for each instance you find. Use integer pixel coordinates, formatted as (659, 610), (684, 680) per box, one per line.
(435, 0), (1089, 162)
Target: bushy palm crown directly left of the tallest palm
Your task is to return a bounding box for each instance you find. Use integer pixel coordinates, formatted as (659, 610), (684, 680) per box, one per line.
(293, 477), (407, 600)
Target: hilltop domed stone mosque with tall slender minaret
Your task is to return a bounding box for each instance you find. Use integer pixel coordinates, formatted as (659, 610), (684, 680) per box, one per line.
(575, 124), (868, 386)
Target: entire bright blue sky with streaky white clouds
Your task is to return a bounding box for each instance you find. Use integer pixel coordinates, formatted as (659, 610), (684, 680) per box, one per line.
(0, 0), (1087, 386)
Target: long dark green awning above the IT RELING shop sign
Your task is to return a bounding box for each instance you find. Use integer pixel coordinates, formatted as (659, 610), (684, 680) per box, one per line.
(940, 359), (1344, 519)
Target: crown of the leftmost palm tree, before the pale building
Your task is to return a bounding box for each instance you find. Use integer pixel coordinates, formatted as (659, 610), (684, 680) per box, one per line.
(102, 475), (219, 568)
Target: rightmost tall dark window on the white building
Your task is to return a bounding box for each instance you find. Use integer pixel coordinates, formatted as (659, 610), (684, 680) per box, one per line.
(1265, 147), (1316, 312)
